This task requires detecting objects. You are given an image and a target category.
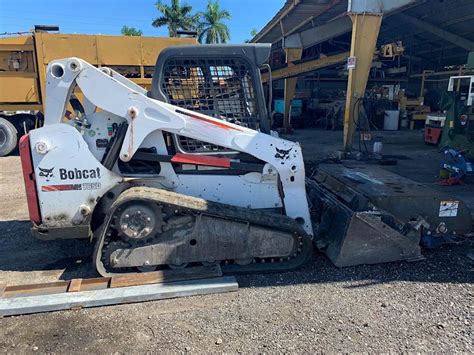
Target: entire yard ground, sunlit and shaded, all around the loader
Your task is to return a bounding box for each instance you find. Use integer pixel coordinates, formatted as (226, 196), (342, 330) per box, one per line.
(0, 130), (474, 353)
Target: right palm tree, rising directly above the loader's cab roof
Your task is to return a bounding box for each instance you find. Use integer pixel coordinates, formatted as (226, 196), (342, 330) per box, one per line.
(198, 0), (232, 43)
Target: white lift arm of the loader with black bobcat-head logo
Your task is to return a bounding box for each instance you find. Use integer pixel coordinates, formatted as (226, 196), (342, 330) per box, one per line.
(41, 58), (313, 235)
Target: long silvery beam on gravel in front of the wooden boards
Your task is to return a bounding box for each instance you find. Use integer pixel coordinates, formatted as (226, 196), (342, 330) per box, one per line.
(0, 276), (239, 316)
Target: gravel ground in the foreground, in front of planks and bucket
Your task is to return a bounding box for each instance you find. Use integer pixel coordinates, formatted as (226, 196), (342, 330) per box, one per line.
(0, 243), (474, 353)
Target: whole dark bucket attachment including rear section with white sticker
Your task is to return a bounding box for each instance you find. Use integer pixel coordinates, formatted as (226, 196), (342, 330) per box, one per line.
(306, 164), (472, 267)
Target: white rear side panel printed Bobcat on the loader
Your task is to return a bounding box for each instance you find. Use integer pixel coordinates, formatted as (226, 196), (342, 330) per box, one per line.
(30, 124), (122, 227)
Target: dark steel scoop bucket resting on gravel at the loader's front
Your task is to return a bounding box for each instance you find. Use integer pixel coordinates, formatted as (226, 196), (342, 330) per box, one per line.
(307, 181), (424, 267)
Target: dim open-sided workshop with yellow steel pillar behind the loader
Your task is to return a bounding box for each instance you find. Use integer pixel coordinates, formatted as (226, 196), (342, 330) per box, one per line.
(248, 0), (474, 213)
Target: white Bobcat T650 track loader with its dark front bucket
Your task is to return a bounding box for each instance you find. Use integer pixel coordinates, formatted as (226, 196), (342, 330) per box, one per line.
(20, 44), (470, 276)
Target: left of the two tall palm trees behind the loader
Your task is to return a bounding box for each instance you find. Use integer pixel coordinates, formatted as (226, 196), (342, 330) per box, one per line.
(151, 0), (199, 37)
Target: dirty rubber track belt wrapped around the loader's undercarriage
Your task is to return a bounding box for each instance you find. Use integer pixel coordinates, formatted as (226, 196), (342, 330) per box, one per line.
(94, 187), (312, 276)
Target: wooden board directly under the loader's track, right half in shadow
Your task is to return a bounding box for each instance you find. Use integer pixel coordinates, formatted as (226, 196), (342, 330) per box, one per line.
(110, 265), (222, 288)
